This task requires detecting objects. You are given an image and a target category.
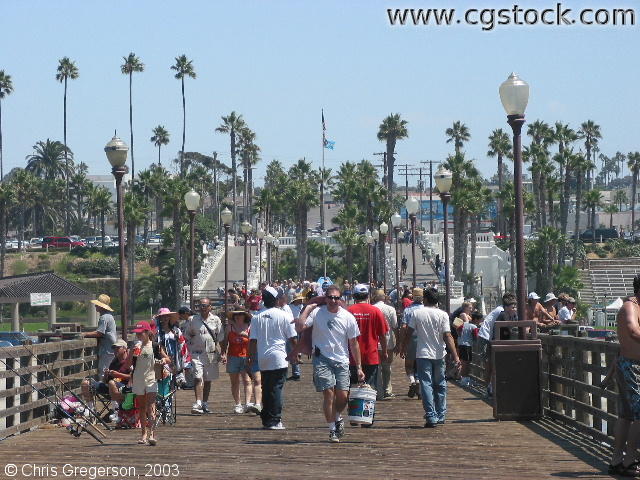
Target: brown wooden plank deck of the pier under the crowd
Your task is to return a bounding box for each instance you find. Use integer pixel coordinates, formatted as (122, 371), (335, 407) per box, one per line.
(0, 360), (610, 480)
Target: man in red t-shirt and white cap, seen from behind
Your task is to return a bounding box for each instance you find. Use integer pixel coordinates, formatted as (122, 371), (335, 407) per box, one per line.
(347, 283), (389, 389)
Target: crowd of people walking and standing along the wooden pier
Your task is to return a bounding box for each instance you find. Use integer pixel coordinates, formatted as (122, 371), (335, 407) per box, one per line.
(76, 280), (575, 445)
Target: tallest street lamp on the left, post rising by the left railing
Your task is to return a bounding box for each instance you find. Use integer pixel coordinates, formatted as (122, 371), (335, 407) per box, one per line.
(104, 135), (129, 341)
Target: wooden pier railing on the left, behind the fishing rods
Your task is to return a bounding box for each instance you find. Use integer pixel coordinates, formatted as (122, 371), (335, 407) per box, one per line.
(0, 339), (96, 439)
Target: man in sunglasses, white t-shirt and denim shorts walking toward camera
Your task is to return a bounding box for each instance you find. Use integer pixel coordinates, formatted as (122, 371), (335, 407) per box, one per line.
(296, 285), (364, 442)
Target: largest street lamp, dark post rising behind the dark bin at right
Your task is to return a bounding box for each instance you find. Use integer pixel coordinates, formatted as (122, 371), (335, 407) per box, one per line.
(499, 73), (529, 320)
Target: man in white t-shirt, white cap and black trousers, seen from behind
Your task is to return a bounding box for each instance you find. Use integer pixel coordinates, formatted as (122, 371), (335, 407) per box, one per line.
(249, 287), (297, 430)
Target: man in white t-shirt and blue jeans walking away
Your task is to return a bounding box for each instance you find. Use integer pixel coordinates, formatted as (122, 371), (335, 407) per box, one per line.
(401, 288), (461, 427)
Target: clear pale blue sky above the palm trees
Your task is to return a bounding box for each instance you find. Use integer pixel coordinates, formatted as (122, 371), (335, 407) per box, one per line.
(0, 0), (640, 185)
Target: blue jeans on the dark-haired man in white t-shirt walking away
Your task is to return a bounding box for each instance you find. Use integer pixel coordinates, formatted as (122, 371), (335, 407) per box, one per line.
(416, 358), (447, 423)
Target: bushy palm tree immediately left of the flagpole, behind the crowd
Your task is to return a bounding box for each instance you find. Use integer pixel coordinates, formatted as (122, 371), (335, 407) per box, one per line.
(287, 159), (320, 280)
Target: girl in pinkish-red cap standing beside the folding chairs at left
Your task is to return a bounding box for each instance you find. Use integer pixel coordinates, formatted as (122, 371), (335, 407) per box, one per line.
(132, 321), (171, 445)
